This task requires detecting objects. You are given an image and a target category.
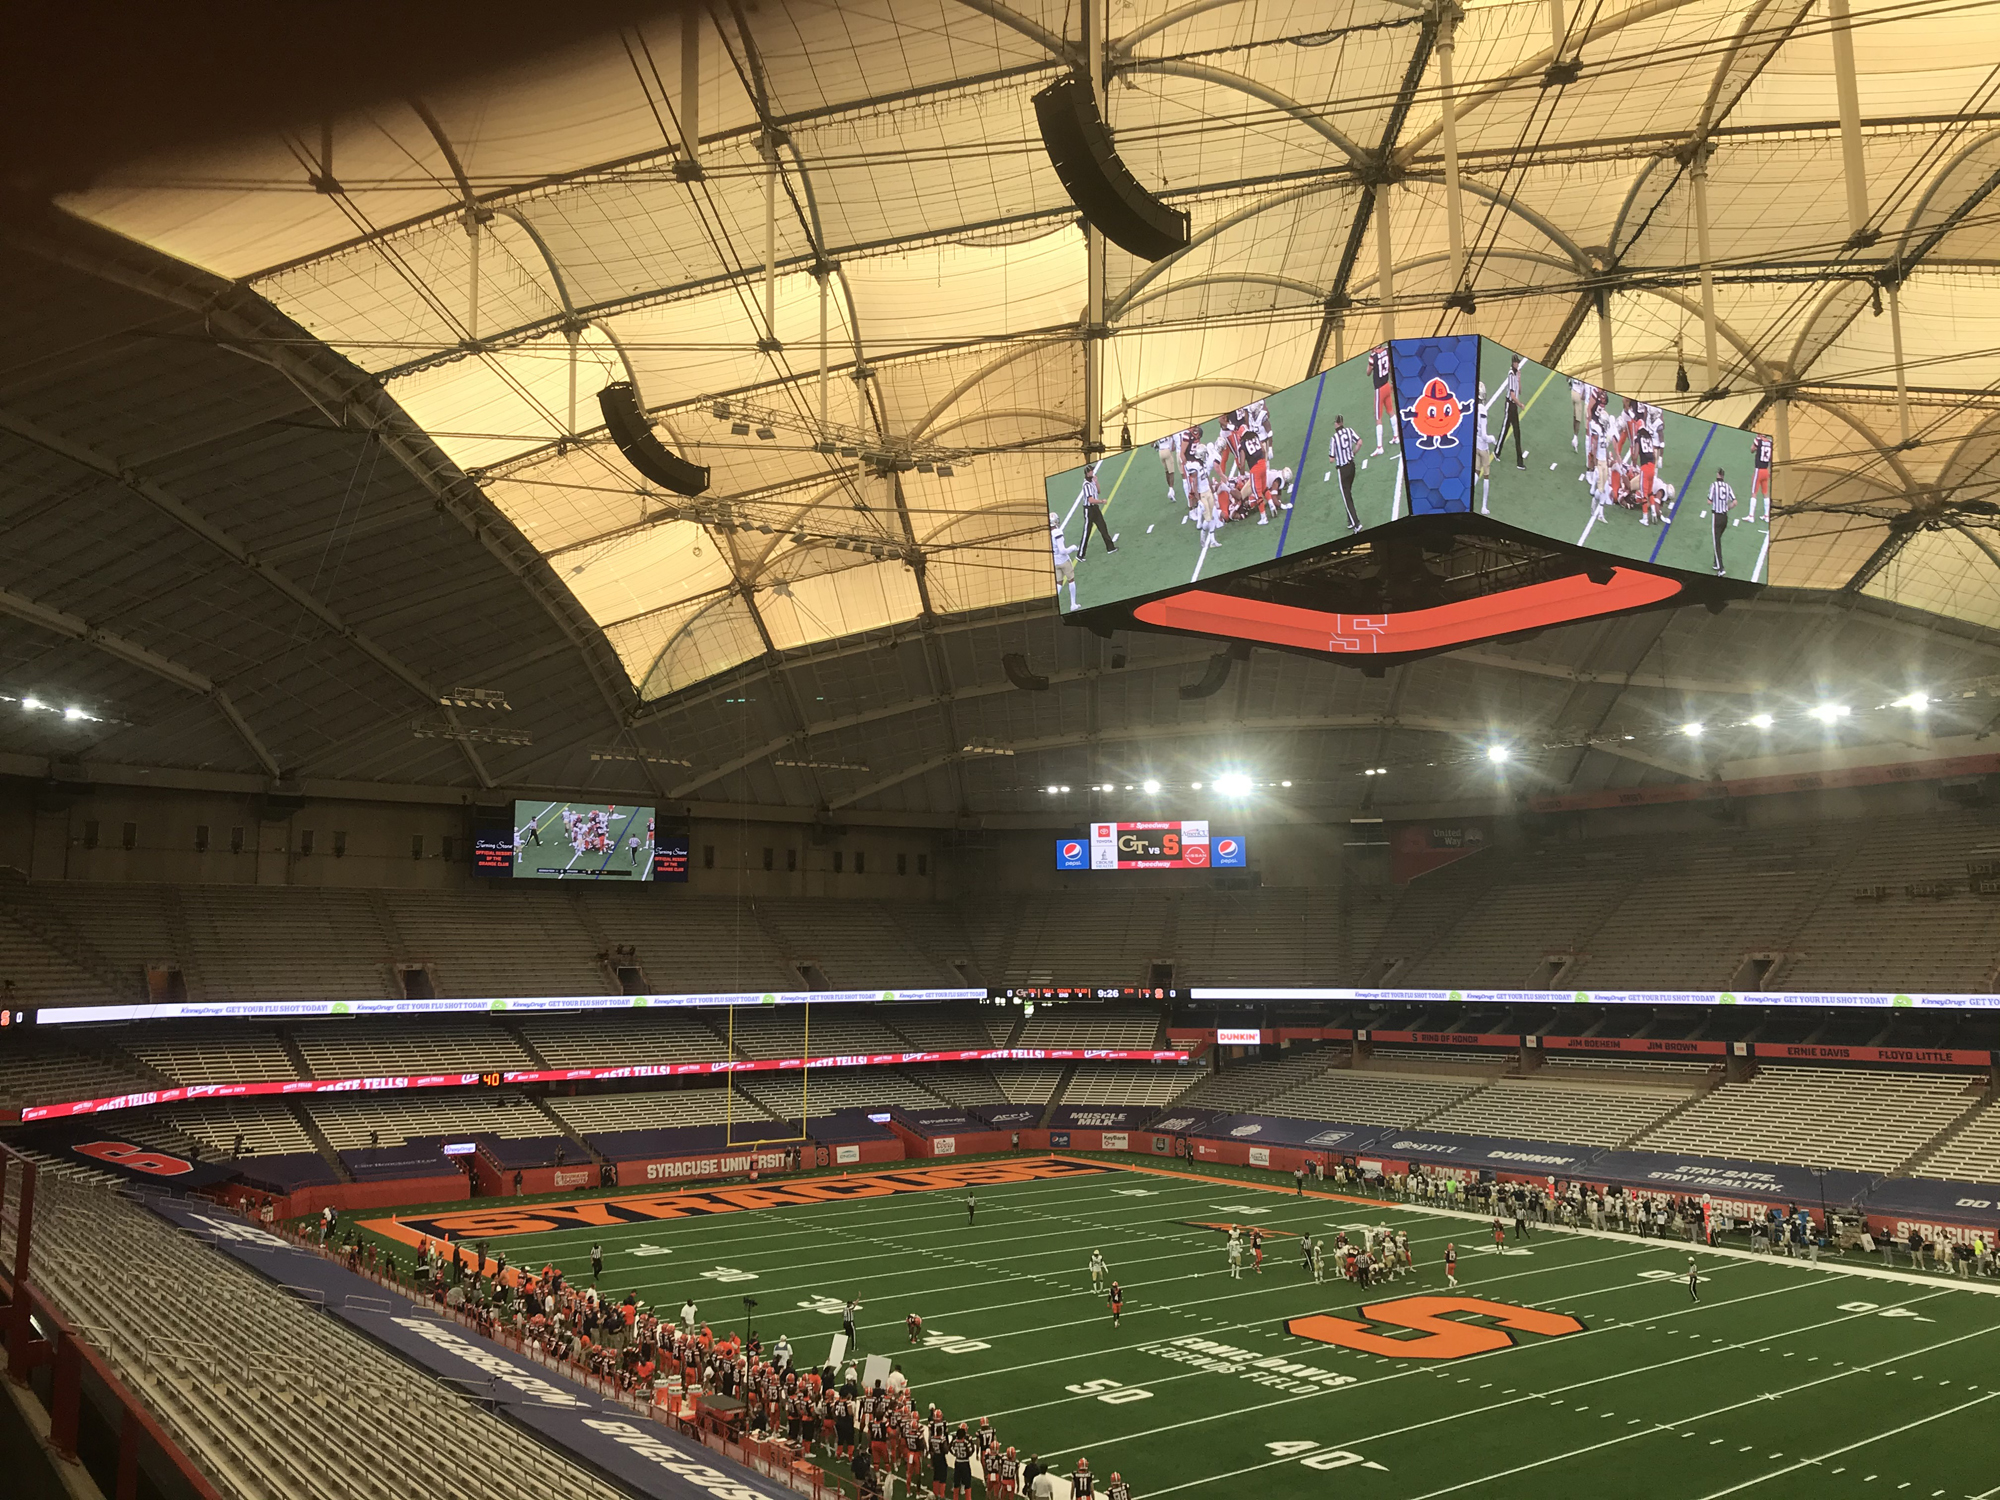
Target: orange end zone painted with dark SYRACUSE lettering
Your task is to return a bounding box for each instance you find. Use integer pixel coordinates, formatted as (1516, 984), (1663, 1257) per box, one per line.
(362, 1156), (1118, 1246)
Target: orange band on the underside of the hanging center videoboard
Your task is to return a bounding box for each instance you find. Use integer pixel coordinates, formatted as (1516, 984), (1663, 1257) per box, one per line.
(1132, 568), (1682, 656)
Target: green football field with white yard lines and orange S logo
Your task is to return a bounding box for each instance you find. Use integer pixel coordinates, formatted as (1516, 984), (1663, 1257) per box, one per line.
(344, 1158), (2000, 1500)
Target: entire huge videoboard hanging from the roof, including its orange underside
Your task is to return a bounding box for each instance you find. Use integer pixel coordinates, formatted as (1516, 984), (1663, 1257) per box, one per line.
(1048, 336), (1772, 658)
